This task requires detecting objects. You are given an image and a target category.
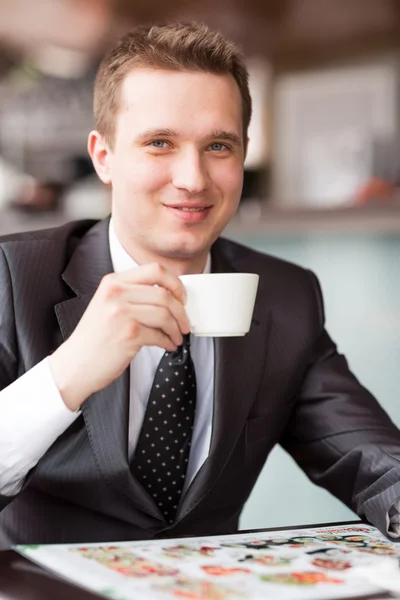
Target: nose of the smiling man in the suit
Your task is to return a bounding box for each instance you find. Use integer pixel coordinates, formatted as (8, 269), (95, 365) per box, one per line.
(172, 150), (209, 194)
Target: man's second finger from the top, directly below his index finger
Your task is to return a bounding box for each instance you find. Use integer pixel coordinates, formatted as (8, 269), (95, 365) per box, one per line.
(121, 284), (190, 333)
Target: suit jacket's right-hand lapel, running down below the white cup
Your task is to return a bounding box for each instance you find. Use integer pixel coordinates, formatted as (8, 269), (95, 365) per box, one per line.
(179, 242), (270, 517)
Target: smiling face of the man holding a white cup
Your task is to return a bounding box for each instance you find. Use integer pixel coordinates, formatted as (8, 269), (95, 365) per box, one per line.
(91, 68), (244, 264)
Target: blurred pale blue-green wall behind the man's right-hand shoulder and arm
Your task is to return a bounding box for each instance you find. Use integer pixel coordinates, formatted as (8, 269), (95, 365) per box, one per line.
(231, 232), (400, 529)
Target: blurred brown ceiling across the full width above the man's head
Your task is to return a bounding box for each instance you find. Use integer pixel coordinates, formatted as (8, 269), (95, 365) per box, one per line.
(0, 0), (400, 66)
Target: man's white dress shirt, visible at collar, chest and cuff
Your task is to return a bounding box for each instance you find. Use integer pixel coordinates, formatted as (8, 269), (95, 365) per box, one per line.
(0, 220), (214, 496)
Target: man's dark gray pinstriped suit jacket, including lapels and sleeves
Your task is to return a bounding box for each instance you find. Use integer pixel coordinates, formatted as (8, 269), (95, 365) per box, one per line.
(0, 220), (400, 547)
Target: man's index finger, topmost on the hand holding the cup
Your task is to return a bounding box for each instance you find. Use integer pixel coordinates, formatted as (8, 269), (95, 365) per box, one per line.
(118, 263), (186, 304)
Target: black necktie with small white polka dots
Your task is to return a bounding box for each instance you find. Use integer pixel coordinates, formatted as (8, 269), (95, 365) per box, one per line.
(131, 335), (196, 523)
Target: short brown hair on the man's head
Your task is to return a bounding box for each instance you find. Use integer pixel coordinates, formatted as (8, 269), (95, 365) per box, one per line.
(94, 23), (251, 146)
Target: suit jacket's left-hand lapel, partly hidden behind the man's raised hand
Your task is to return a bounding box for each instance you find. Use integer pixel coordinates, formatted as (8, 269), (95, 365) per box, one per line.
(55, 219), (160, 518)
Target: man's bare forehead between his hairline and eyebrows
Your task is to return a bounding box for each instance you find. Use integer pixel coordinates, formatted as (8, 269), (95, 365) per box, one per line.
(117, 68), (242, 135)
